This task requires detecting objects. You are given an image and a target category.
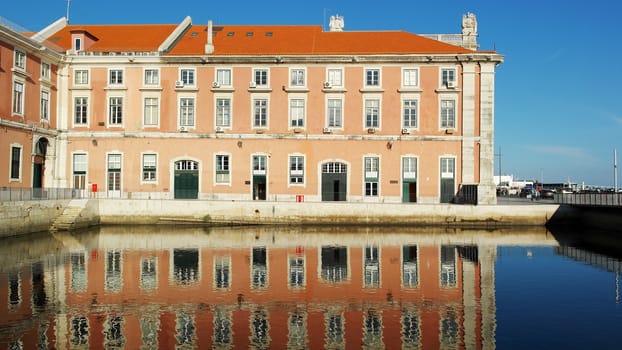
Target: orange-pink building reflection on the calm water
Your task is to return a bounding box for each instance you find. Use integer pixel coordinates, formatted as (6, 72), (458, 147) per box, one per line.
(0, 227), (555, 349)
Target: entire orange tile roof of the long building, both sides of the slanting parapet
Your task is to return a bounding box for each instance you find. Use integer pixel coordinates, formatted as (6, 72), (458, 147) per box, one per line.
(49, 24), (472, 56)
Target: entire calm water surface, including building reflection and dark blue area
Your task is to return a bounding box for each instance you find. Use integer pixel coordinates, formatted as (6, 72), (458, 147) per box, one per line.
(0, 227), (622, 349)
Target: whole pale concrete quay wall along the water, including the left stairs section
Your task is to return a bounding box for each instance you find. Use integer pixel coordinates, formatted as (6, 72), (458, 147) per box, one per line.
(0, 199), (564, 237)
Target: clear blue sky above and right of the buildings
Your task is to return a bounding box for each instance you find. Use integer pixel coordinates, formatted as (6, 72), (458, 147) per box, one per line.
(0, 0), (622, 186)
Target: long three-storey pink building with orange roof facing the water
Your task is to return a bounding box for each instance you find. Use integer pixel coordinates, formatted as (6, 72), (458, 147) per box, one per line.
(0, 14), (503, 204)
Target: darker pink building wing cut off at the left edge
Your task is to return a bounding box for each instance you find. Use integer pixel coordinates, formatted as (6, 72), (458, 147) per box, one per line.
(0, 20), (62, 196)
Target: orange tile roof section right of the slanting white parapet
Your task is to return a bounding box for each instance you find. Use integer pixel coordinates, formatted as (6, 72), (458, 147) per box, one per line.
(169, 25), (472, 55)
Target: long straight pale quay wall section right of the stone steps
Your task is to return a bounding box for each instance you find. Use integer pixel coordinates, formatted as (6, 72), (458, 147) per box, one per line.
(99, 200), (558, 227)
